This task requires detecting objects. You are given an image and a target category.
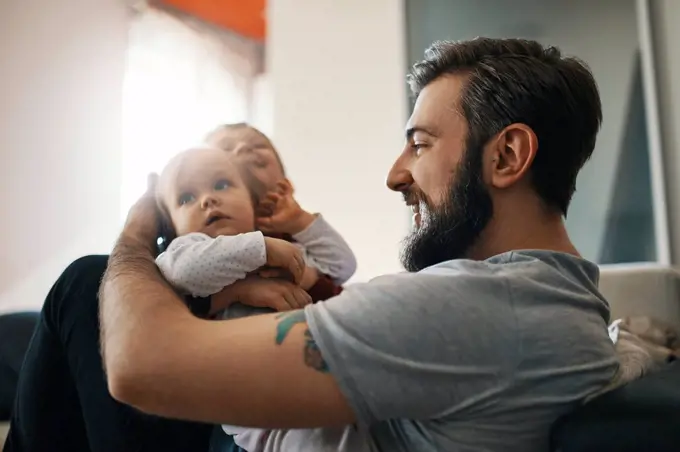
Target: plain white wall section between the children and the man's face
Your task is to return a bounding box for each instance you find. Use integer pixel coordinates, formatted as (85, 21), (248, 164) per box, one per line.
(266, 0), (410, 280)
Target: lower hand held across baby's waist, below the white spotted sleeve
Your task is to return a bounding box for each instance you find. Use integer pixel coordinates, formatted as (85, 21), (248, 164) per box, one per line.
(211, 276), (312, 312)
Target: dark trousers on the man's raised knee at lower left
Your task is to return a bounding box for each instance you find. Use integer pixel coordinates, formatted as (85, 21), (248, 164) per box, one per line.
(4, 256), (236, 452)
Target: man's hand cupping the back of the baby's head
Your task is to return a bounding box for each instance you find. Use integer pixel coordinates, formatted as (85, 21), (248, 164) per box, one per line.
(121, 174), (158, 250)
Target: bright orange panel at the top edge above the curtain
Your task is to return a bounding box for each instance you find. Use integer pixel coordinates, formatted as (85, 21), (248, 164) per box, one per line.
(158, 0), (266, 41)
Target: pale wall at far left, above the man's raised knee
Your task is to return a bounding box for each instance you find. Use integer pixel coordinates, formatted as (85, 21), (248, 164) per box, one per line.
(0, 0), (127, 311)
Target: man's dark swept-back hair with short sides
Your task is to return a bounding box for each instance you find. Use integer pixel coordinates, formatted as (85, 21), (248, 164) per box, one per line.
(408, 38), (602, 216)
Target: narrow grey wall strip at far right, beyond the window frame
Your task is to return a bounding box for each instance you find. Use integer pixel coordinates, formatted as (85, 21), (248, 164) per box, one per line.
(650, 0), (680, 265)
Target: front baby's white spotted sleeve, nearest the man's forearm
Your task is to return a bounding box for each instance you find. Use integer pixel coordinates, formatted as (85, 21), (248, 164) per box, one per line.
(156, 232), (267, 297)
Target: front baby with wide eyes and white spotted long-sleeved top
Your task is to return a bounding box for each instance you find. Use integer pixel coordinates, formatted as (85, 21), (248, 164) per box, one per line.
(156, 147), (311, 317)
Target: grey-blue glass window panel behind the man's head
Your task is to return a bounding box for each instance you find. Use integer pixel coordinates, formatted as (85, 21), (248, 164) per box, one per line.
(406, 0), (670, 264)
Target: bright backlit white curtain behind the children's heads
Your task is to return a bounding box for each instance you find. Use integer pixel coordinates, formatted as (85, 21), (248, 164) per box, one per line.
(121, 6), (263, 215)
